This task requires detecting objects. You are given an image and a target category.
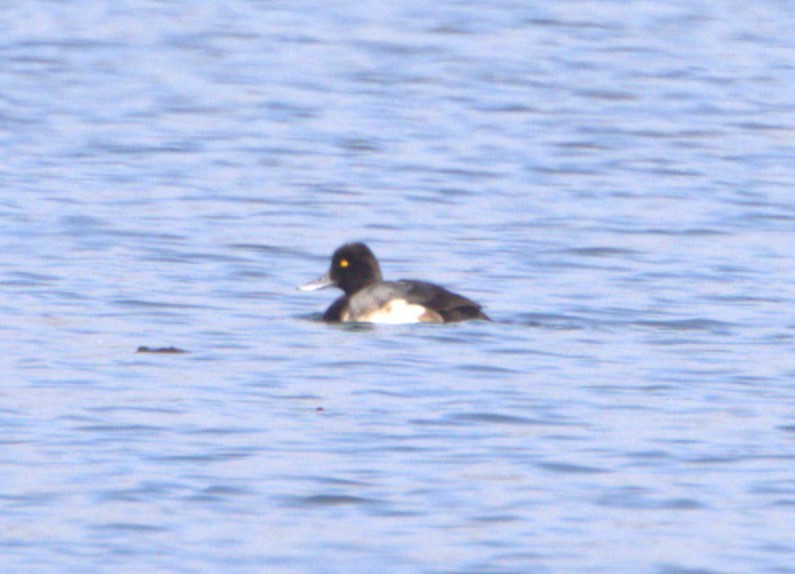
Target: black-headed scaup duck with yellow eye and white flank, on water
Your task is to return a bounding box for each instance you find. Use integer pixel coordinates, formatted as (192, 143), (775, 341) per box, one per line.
(299, 243), (490, 323)
